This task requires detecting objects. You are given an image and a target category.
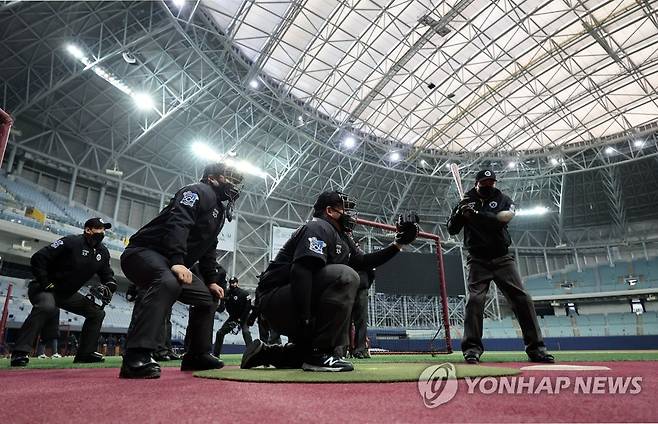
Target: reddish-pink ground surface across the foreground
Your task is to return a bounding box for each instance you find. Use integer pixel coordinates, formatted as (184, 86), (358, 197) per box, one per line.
(0, 362), (658, 424)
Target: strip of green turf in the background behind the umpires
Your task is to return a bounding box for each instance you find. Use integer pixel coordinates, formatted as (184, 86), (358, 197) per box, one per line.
(0, 350), (658, 369)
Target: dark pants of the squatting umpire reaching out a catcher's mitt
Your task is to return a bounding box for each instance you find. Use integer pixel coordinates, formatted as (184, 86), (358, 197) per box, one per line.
(260, 264), (359, 353)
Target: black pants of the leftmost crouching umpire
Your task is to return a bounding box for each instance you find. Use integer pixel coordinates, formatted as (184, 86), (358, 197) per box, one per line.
(14, 281), (105, 355)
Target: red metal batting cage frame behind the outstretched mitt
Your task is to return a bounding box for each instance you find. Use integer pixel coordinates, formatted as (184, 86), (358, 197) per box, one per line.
(356, 218), (453, 356)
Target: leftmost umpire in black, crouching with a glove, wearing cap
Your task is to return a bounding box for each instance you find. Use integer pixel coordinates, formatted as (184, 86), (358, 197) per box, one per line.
(11, 218), (117, 366)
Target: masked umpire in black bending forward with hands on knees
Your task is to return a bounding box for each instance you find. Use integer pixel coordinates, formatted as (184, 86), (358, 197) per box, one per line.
(119, 163), (242, 378)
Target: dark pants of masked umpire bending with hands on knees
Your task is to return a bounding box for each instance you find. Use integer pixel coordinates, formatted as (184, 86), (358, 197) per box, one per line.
(121, 248), (217, 354)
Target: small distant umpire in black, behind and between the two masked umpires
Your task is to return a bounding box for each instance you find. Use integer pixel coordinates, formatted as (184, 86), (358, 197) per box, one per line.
(213, 277), (252, 357)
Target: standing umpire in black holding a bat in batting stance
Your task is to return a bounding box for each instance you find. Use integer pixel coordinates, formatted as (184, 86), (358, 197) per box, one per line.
(448, 170), (554, 364)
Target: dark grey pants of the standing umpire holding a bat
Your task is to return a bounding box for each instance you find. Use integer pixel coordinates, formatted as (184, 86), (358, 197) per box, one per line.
(462, 255), (546, 355)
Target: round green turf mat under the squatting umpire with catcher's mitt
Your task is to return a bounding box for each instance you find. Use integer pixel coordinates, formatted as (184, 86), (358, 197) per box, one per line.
(194, 362), (520, 383)
